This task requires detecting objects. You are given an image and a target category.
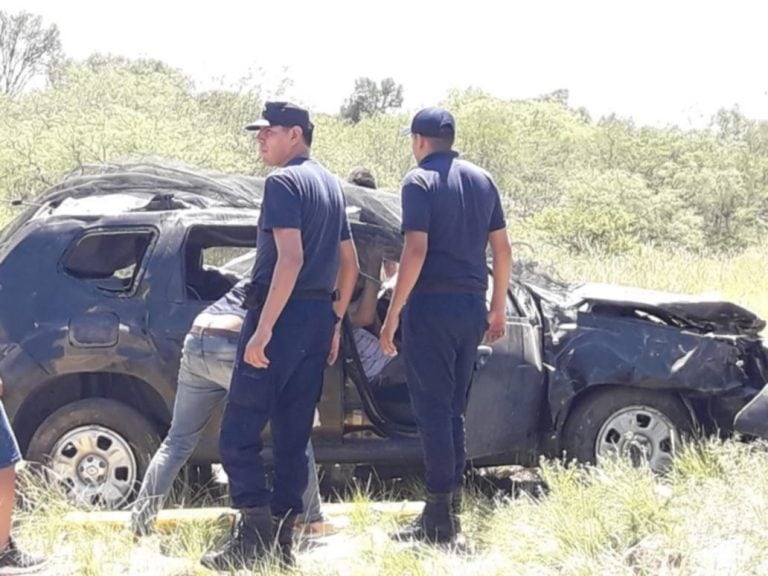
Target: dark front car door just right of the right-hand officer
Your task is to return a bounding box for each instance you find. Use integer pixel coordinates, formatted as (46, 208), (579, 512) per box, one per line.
(466, 283), (546, 464)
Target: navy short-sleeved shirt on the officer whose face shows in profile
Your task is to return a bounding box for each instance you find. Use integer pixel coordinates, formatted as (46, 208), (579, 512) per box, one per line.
(251, 157), (351, 294)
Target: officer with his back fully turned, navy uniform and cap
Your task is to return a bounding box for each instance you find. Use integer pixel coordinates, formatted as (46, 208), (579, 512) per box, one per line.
(380, 108), (511, 542)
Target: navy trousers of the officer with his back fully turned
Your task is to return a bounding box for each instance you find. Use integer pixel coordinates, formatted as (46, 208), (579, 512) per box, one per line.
(402, 293), (487, 493)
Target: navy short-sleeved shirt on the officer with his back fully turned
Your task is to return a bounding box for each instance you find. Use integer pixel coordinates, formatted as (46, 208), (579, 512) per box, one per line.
(401, 151), (506, 293)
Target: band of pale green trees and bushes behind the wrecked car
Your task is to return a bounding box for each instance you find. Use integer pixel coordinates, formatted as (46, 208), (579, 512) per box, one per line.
(0, 12), (768, 254)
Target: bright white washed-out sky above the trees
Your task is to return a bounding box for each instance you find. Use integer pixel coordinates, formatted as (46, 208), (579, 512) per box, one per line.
(6, 0), (768, 128)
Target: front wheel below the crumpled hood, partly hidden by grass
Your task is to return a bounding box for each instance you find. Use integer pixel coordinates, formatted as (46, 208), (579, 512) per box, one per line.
(561, 386), (693, 472)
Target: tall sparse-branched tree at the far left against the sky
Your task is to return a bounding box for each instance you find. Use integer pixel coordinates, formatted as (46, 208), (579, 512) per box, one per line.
(0, 11), (61, 96)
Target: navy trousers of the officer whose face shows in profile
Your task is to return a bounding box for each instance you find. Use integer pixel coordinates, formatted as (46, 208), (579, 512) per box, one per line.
(219, 298), (335, 516)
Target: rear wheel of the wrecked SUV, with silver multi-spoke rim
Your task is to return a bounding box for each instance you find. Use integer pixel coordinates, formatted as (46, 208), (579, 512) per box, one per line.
(26, 398), (160, 509)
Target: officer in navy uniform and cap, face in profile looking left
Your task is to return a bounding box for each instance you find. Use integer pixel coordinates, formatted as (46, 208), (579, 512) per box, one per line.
(202, 102), (358, 570)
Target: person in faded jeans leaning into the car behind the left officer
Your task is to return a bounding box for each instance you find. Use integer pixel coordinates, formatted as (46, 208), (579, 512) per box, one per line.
(131, 280), (329, 536)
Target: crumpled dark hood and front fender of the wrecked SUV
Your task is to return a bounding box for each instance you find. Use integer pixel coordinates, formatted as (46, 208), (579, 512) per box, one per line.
(519, 267), (768, 426)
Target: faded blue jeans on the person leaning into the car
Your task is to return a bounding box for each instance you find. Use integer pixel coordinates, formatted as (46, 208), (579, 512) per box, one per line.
(131, 334), (322, 532)
